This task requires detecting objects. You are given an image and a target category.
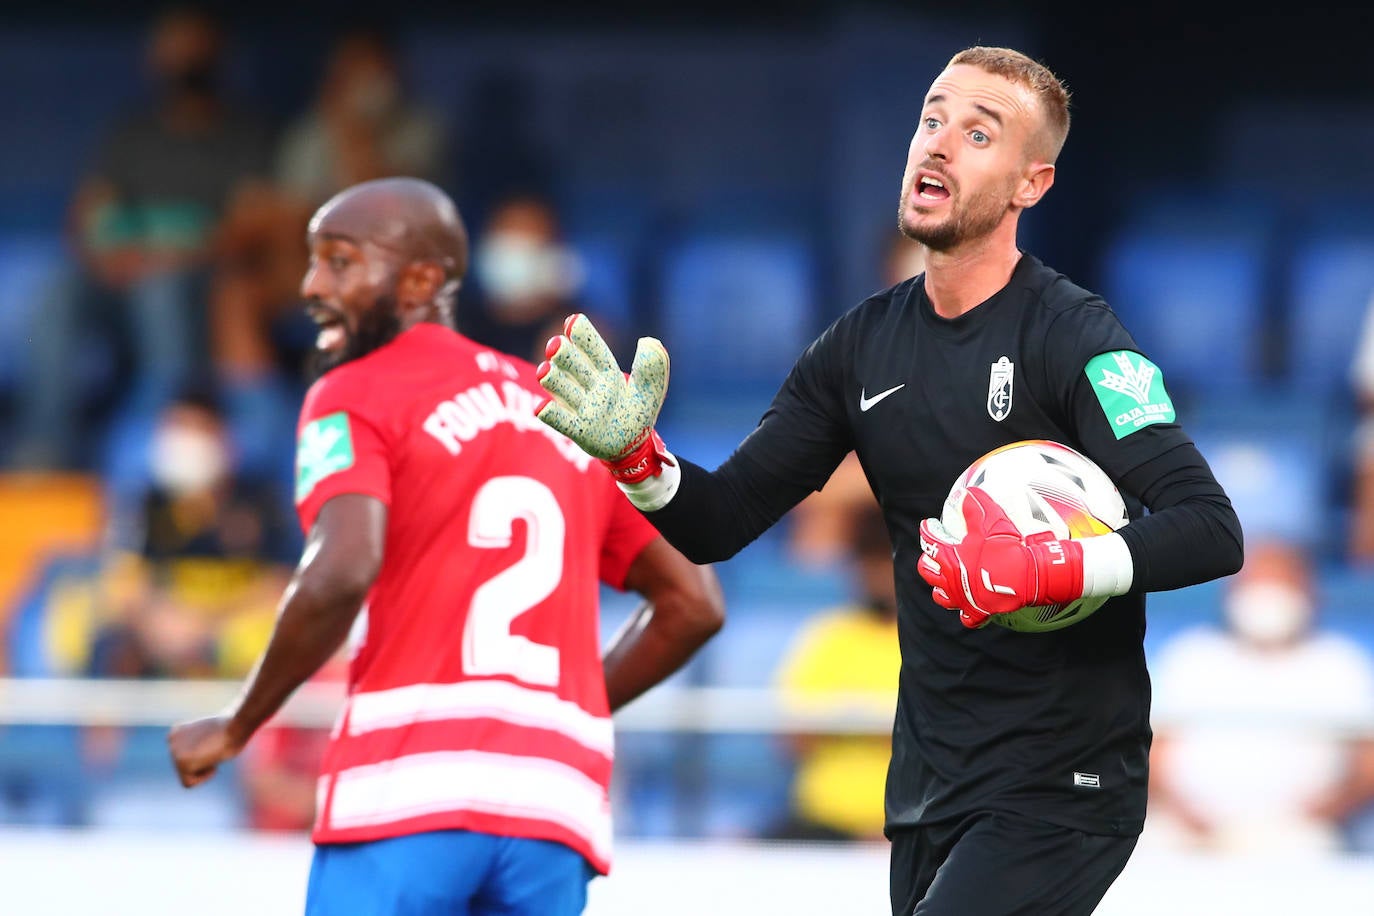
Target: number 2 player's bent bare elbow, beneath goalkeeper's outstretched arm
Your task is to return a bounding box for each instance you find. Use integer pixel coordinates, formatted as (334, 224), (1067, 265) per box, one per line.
(602, 537), (725, 711)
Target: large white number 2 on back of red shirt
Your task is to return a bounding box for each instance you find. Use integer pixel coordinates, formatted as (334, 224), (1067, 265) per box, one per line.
(463, 477), (566, 687)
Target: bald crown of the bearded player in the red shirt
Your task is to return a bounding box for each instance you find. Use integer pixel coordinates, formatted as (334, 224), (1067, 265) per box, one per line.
(309, 179), (467, 282)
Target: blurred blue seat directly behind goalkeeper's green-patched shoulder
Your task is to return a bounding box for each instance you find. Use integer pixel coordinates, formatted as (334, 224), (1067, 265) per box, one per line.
(1103, 225), (1267, 394)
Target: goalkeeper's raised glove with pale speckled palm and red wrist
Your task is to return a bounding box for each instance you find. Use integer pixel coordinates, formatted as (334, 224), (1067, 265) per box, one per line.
(534, 314), (672, 483)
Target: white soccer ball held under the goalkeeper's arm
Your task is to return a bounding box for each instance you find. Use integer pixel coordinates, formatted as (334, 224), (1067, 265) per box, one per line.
(940, 439), (1127, 633)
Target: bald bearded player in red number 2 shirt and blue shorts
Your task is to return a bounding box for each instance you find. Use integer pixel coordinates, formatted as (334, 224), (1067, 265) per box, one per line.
(168, 179), (724, 916)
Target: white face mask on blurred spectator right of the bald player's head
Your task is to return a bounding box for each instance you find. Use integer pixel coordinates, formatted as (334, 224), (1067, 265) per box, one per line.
(473, 232), (583, 314)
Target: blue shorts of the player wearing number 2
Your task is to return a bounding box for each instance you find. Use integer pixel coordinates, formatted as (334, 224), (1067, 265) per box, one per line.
(305, 829), (595, 916)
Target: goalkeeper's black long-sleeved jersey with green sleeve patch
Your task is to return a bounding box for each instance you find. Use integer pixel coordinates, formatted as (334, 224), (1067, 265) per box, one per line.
(647, 255), (1241, 834)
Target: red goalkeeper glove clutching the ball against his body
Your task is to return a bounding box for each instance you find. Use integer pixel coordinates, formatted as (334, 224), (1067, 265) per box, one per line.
(916, 486), (1083, 629)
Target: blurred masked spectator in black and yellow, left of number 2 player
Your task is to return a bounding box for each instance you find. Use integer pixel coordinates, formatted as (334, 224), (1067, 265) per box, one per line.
(89, 393), (290, 677)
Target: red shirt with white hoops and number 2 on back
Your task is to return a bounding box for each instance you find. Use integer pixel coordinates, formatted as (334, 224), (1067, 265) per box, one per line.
(295, 324), (657, 873)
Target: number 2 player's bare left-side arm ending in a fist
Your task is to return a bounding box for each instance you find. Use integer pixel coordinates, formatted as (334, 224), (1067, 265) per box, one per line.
(168, 494), (386, 788)
